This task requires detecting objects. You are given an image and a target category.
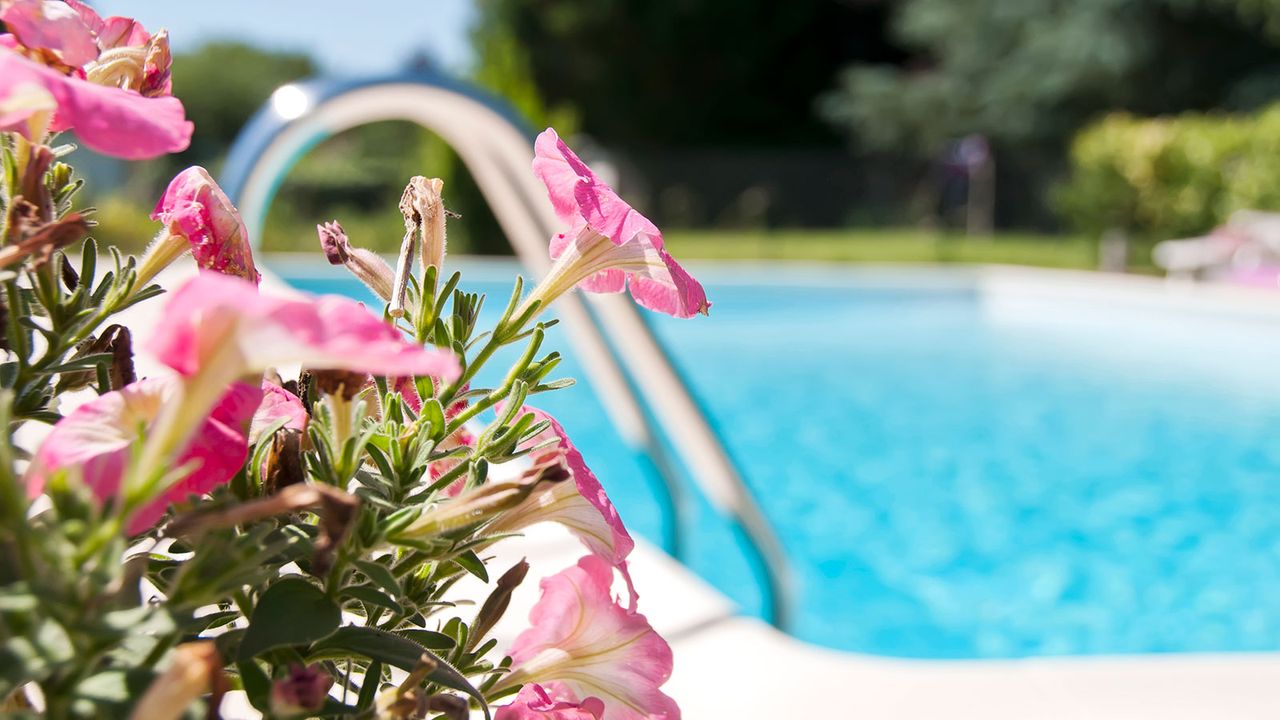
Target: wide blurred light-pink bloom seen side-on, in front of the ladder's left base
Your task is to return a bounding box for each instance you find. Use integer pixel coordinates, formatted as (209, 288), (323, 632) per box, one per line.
(150, 273), (461, 380)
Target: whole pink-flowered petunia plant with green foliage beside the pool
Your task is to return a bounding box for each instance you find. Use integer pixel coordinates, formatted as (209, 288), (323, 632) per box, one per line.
(0, 0), (709, 720)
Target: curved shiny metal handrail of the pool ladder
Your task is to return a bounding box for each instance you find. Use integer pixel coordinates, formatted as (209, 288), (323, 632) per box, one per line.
(223, 74), (794, 630)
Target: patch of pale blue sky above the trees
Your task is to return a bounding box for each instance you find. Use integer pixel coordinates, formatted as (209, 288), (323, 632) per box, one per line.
(92, 0), (475, 76)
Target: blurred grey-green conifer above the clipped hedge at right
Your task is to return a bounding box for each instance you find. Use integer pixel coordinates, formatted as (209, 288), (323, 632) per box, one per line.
(820, 0), (1280, 154)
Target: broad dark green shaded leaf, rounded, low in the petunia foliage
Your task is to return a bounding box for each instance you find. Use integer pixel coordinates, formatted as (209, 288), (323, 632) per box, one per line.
(239, 578), (342, 660)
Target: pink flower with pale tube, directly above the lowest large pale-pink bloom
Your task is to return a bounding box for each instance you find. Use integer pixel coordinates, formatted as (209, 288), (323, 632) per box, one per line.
(490, 406), (636, 597)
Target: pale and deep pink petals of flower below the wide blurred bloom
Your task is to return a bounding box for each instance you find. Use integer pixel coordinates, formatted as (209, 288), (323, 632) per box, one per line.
(26, 378), (262, 534)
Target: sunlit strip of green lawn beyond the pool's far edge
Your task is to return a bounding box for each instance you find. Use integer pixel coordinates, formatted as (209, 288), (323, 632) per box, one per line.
(666, 229), (1111, 269)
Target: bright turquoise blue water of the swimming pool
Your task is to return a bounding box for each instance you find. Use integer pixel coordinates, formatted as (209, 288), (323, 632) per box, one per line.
(276, 260), (1280, 657)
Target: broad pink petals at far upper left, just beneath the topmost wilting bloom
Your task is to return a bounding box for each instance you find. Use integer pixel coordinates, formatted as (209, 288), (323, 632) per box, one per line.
(0, 43), (192, 160)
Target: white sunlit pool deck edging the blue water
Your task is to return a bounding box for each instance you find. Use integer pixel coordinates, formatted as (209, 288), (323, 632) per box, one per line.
(128, 258), (1280, 720)
